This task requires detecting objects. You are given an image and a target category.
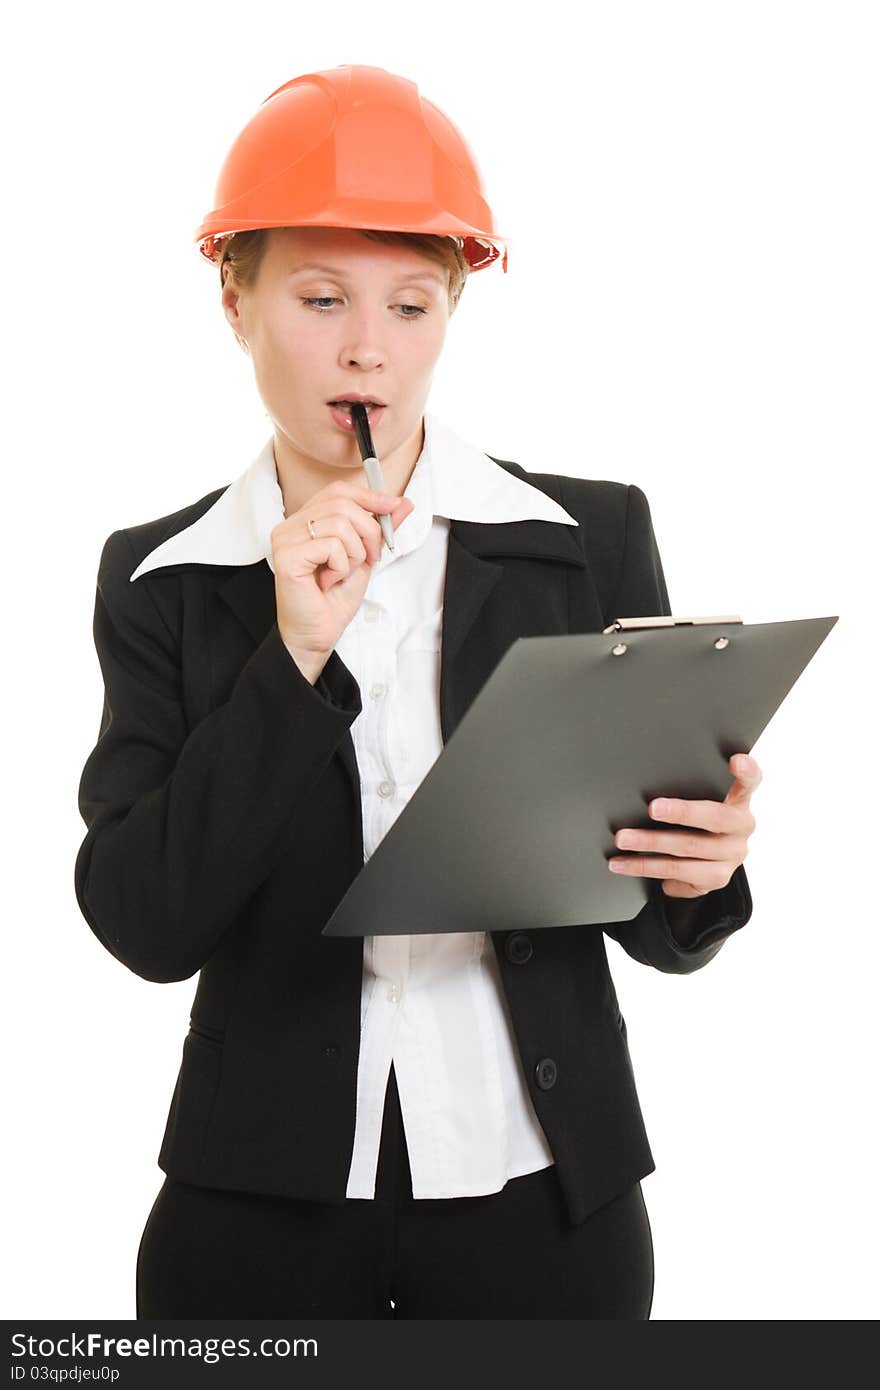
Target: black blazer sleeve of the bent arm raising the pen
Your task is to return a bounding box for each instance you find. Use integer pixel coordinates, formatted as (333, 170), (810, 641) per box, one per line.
(74, 531), (361, 981)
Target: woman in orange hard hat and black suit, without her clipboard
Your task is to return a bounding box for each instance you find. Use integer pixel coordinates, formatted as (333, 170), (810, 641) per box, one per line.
(75, 67), (760, 1319)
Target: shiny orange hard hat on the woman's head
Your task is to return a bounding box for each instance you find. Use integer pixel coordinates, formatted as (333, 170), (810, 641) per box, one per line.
(195, 65), (509, 272)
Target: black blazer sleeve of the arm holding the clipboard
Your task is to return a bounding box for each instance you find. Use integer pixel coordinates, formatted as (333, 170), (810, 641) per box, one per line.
(605, 484), (752, 974)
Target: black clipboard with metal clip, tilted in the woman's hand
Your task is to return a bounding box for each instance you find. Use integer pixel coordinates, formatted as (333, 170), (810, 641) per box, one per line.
(323, 616), (837, 937)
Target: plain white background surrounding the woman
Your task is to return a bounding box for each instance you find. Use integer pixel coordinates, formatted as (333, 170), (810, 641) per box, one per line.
(3, 0), (880, 1319)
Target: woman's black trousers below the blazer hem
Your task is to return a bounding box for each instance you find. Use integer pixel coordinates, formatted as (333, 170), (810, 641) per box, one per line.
(136, 1066), (653, 1321)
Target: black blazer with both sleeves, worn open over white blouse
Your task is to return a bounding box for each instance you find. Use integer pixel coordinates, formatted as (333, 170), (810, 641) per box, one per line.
(75, 459), (752, 1223)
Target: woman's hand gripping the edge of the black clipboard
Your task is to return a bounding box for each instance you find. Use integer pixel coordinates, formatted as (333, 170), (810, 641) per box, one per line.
(608, 753), (762, 898)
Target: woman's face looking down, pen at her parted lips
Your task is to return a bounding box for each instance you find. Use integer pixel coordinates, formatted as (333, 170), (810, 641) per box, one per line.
(222, 227), (449, 513)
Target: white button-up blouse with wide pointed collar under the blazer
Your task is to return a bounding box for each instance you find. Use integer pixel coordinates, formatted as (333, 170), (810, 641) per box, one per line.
(132, 413), (577, 1198)
